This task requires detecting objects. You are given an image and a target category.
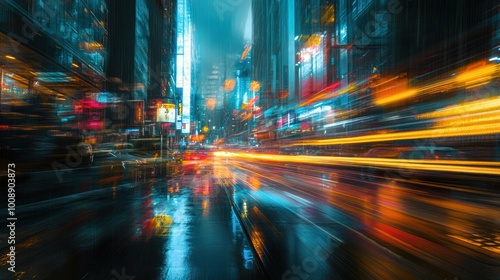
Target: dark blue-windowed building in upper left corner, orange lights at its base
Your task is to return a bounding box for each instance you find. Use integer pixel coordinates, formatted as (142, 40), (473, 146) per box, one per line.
(0, 0), (108, 104)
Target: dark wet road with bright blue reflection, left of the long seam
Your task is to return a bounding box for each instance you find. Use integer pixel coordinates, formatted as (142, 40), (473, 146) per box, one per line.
(0, 161), (266, 280)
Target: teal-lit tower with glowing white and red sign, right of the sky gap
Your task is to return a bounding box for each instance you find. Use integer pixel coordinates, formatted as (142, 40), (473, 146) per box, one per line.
(252, 0), (335, 140)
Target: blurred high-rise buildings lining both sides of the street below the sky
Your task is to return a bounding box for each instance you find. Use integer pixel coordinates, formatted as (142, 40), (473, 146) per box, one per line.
(0, 0), (500, 150)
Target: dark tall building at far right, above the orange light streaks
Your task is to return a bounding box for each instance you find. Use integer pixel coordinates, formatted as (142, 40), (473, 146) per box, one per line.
(335, 0), (499, 115)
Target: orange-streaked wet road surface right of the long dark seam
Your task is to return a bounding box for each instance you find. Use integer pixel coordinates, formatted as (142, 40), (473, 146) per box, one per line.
(215, 158), (500, 279)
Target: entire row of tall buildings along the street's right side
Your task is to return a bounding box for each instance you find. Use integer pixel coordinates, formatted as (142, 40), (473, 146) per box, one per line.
(251, 0), (500, 142)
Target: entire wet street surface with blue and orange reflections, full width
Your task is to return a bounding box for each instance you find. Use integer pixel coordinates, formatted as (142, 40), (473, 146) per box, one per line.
(0, 159), (500, 280)
